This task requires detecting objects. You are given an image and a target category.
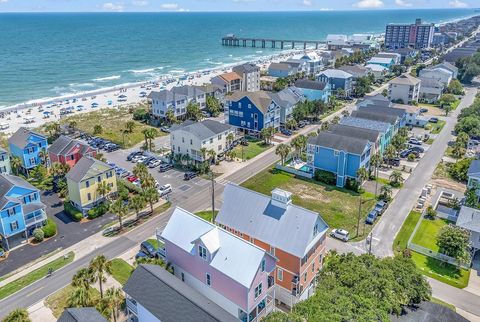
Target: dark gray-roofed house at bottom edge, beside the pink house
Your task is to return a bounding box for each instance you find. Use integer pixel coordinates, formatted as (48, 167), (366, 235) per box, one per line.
(123, 264), (238, 322)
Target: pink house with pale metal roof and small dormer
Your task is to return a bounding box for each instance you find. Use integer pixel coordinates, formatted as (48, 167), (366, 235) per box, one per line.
(160, 208), (276, 322)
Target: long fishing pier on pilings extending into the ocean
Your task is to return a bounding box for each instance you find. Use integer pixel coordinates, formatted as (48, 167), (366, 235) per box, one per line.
(222, 34), (326, 49)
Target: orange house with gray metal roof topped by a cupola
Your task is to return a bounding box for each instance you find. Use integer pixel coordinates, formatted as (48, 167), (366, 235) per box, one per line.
(215, 183), (328, 307)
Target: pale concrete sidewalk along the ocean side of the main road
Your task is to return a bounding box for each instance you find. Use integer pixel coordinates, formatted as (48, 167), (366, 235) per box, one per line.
(0, 199), (166, 287)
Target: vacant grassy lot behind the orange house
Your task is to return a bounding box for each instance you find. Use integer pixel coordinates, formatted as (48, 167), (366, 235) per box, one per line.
(242, 169), (376, 238)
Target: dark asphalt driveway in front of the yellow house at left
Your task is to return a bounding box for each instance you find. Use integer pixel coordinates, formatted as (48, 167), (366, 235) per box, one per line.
(0, 193), (115, 276)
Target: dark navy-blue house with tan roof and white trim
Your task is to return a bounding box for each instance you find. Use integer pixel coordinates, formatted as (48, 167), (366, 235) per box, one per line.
(225, 91), (281, 132)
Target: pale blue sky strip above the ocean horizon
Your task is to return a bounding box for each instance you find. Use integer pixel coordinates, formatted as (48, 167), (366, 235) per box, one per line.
(0, 0), (480, 12)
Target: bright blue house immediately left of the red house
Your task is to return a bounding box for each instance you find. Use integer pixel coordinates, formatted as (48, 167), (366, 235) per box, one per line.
(8, 127), (48, 173)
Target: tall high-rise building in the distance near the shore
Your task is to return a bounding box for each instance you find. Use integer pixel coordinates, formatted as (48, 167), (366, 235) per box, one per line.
(385, 19), (435, 49)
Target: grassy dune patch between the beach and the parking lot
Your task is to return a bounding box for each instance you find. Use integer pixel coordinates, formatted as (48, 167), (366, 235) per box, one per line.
(55, 108), (167, 148)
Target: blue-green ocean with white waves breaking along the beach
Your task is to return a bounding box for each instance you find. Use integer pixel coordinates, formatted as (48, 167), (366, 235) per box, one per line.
(0, 9), (475, 107)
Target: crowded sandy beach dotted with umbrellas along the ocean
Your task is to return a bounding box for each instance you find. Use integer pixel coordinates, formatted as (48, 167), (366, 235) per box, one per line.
(0, 48), (324, 134)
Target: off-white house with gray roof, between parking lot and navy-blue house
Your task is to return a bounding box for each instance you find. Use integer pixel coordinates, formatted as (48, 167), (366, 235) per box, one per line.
(170, 120), (235, 162)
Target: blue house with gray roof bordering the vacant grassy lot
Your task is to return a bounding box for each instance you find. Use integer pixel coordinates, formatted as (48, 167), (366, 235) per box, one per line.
(307, 132), (372, 187)
